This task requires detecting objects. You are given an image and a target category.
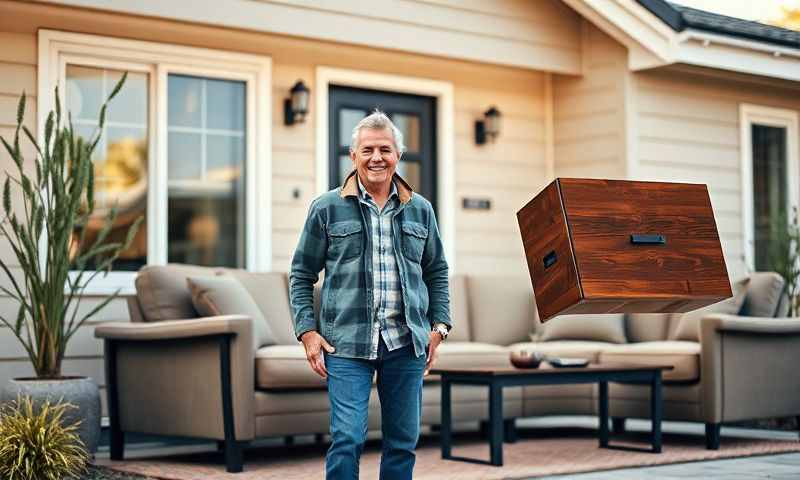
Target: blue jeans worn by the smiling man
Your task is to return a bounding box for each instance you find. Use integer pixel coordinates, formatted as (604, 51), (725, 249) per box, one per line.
(323, 338), (427, 480)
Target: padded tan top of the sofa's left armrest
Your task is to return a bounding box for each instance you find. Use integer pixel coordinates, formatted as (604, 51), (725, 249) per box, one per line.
(94, 315), (252, 340)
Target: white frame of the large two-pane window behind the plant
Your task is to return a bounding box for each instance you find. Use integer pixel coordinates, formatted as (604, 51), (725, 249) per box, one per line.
(37, 29), (272, 295)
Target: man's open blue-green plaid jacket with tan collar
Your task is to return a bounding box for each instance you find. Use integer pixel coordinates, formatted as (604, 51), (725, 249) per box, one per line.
(289, 171), (452, 358)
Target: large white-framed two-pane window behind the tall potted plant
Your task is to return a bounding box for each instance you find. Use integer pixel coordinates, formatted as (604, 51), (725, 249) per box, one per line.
(39, 31), (271, 294)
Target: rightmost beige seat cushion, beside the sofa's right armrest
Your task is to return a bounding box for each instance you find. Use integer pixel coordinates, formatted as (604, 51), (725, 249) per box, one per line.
(600, 340), (700, 382)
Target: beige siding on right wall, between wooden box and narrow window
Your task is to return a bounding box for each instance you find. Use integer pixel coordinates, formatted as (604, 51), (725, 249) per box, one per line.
(634, 68), (800, 279)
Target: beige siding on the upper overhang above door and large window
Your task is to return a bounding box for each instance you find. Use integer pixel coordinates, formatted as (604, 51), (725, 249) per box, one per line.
(43, 0), (580, 74)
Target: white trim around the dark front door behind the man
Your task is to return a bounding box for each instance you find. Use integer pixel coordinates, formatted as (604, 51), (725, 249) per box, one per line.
(316, 67), (456, 274)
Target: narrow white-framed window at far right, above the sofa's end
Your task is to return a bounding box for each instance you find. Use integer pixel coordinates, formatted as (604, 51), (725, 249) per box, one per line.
(741, 105), (800, 271)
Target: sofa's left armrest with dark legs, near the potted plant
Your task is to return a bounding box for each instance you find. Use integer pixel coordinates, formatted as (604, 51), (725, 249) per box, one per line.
(95, 315), (255, 441)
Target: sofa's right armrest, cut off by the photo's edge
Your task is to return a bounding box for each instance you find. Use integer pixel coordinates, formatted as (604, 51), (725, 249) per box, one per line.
(700, 314), (800, 423)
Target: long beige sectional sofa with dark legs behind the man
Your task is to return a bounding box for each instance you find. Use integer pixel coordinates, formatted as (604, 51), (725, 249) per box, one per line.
(95, 264), (800, 472)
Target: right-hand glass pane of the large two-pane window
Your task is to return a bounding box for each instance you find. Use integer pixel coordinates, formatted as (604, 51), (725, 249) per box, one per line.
(167, 75), (246, 267)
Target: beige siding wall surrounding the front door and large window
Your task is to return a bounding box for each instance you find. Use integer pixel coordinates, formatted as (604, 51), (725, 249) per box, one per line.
(0, 0), (552, 404)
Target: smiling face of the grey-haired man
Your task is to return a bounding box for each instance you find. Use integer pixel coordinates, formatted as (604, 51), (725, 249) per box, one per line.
(350, 128), (400, 191)
